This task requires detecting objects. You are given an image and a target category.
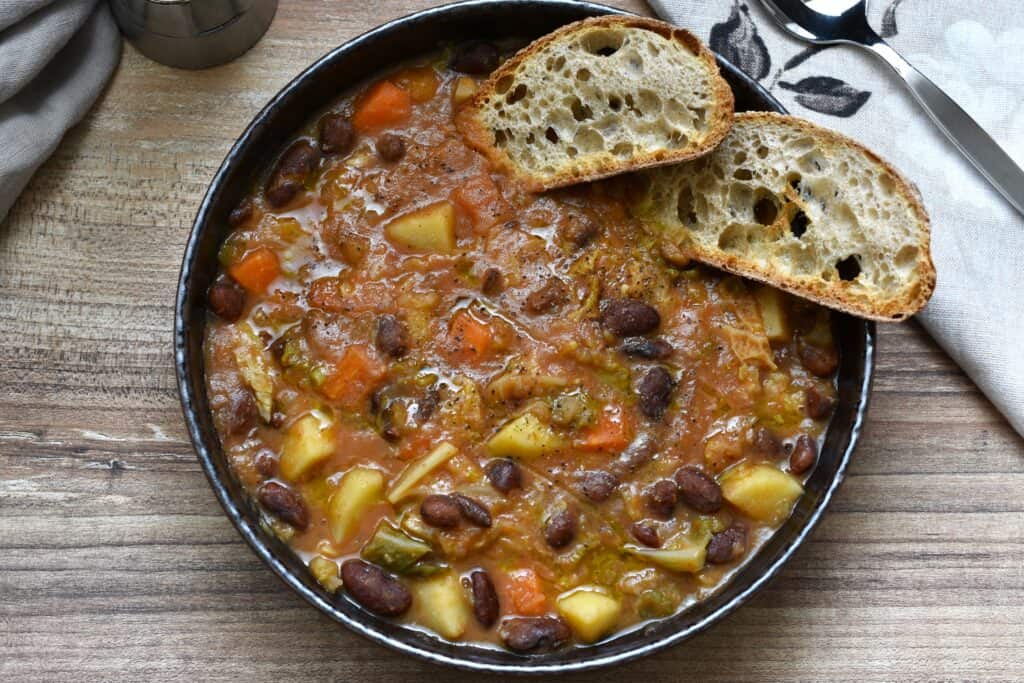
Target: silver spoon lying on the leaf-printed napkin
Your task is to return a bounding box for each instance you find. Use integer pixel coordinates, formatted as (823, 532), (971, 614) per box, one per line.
(761, 0), (1024, 214)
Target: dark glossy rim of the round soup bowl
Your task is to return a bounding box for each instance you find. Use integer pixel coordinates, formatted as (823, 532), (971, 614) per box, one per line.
(174, 0), (876, 675)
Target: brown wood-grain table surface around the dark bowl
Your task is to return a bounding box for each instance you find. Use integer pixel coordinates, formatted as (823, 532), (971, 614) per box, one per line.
(0, 0), (1024, 683)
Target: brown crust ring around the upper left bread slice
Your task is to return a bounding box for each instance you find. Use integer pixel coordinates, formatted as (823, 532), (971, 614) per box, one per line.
(456, 14), (735, 193)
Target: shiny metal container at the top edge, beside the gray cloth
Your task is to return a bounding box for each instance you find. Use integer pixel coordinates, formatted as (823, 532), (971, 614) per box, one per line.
(111, 0), (278, 69)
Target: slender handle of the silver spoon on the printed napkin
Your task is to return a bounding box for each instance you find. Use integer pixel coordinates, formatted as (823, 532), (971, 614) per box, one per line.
(863, 38), (1024, 219)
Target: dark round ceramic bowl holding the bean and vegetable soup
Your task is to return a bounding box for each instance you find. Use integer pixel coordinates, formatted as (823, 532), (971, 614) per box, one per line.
(174, 0), (874, 673)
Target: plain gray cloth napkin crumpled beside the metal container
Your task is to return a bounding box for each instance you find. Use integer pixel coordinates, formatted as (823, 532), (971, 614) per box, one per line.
(0, 0), (121, 220)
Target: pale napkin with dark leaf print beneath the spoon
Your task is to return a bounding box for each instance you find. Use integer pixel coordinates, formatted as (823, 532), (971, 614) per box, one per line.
(649, 0), (1024, 434)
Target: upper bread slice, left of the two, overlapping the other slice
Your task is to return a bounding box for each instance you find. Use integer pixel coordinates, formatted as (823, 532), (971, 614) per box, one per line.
(456, 16), (733, 191)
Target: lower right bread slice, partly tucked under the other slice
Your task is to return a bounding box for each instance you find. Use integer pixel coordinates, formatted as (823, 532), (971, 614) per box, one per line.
(637, 113), (935, 321)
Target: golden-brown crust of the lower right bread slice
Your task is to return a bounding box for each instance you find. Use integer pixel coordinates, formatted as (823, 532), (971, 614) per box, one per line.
(655, 112), (936, 323)
